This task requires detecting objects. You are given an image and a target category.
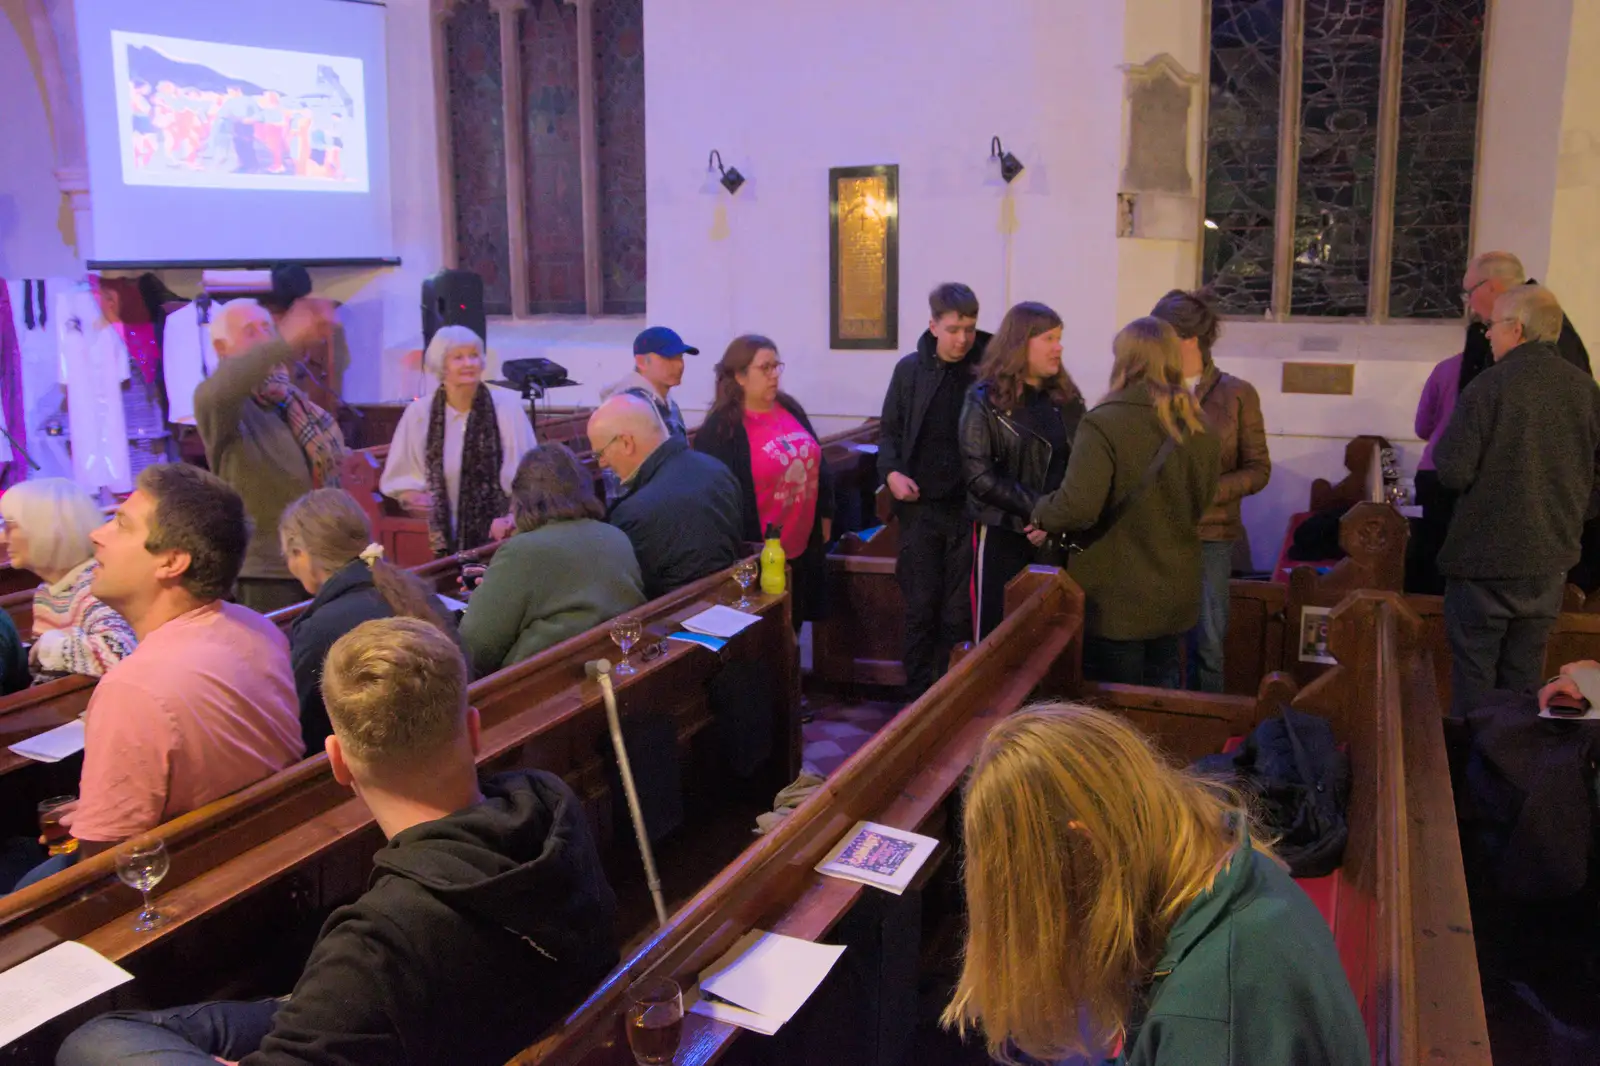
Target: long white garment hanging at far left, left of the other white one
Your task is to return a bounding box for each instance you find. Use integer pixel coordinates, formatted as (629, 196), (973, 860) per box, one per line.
(51, 288), (133, 493)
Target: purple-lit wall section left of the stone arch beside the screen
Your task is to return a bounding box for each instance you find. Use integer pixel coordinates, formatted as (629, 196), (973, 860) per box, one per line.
(0, 0), (80, 279)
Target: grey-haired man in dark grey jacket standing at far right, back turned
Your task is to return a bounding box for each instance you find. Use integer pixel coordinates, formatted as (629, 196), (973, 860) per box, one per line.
(1434, 285), (1600, 715)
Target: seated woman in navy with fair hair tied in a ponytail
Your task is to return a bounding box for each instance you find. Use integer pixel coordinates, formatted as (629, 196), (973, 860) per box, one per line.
(278, 488), (456, 755)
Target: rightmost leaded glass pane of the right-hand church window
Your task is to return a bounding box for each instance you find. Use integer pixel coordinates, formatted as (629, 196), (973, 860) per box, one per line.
(1389, 0), (1485, 319)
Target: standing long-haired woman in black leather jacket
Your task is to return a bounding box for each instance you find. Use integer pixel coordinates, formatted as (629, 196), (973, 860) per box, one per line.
(962, 303), (1085, 640)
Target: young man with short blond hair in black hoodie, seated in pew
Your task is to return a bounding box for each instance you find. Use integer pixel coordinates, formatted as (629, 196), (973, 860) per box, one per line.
(56, 618), (618, 1066)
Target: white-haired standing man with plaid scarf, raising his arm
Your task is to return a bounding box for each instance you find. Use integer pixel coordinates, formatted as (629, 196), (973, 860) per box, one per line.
(195, 298), (344, 613)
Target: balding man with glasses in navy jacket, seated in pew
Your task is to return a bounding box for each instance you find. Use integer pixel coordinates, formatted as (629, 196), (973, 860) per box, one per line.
(589, 392), (744, 599)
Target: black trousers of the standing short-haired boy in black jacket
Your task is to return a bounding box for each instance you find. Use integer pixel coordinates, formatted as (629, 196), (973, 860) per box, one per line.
(894, 499), (973, 699)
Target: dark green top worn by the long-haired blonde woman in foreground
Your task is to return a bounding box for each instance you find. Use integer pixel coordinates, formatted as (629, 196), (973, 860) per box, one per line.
(1125, 842), (1373, 1066)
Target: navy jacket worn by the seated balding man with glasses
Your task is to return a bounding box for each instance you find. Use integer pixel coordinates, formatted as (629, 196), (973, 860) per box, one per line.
(606, 437), (744, 600)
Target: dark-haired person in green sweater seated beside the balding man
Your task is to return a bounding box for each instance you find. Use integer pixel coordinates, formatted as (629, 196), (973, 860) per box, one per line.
(461, 445), (645, 677)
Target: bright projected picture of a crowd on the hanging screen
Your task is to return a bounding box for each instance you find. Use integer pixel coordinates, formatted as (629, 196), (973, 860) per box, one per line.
(112, 30), (368, 192)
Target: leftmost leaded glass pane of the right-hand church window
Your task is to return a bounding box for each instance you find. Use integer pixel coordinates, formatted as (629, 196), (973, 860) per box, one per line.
(1202, 0), (1283, 315)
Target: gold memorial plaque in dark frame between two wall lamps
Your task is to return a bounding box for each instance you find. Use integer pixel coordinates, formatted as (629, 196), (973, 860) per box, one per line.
(827, 165), (899, 351)
